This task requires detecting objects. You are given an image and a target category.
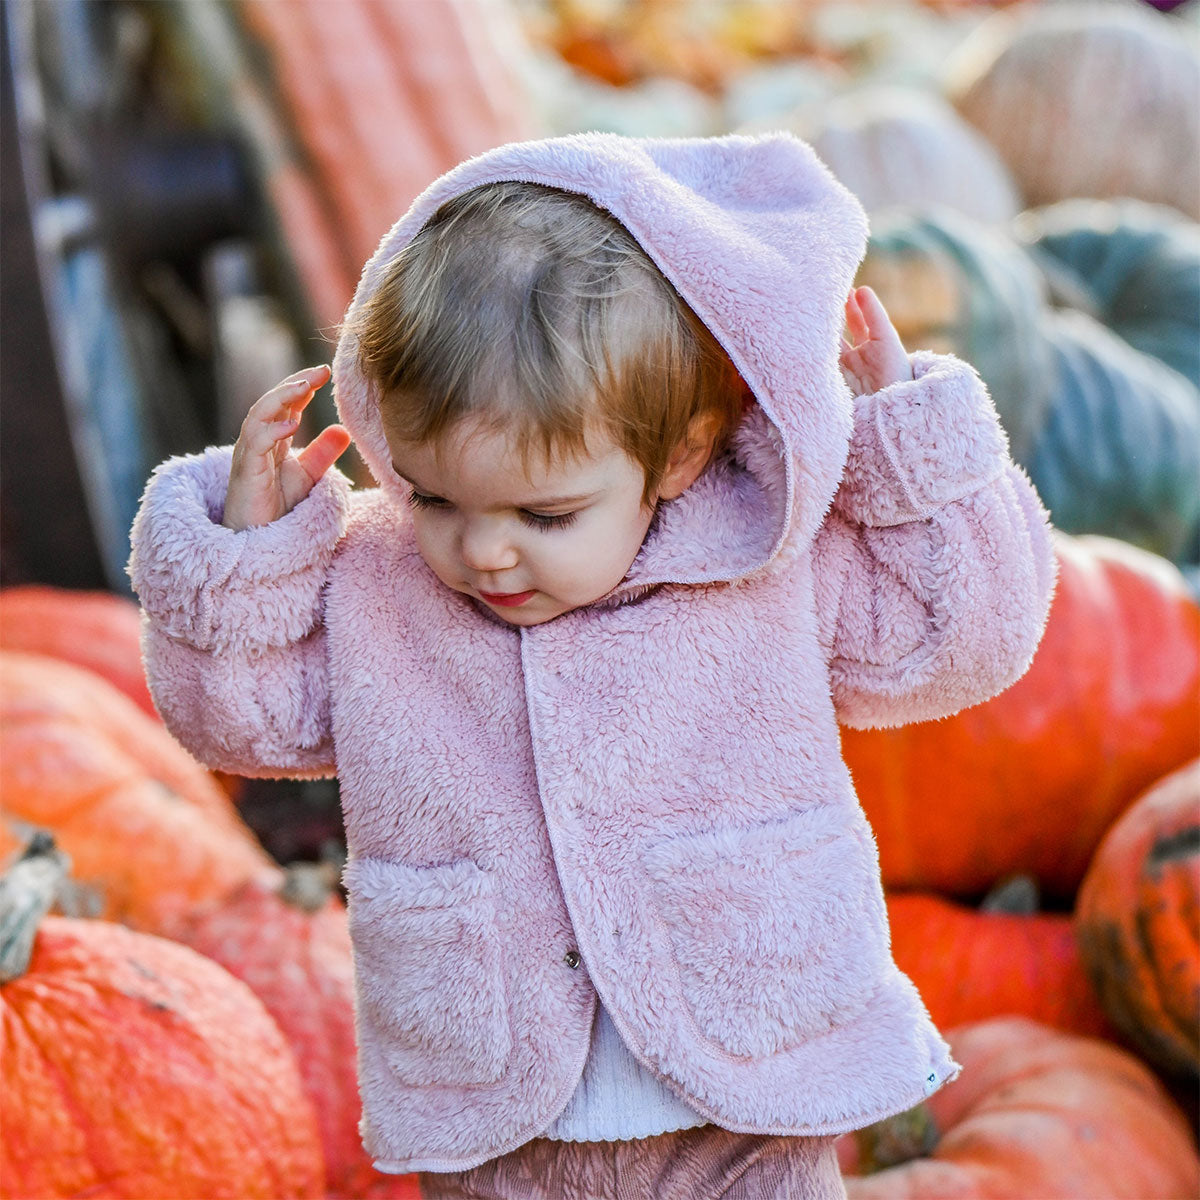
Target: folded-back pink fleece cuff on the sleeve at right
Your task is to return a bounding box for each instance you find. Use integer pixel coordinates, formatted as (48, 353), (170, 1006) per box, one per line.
(834, 350), (1009, 526)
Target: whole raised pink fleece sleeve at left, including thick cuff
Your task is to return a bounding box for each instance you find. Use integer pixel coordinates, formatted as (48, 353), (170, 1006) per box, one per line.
(128, 446), (350, 778)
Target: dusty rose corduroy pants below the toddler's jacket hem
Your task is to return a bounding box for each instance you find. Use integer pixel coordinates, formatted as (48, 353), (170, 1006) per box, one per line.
(420, 1126), (846, 1200)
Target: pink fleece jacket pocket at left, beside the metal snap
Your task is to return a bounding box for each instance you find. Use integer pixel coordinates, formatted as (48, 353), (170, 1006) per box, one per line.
(342, 858), (512, 1086)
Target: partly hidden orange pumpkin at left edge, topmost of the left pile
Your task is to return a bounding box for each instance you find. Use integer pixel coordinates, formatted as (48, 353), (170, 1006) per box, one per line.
(0, 583), (157, 718)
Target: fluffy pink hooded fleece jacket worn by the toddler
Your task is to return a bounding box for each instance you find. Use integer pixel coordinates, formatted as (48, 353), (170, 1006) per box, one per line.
(131, 134), (1054, 1171)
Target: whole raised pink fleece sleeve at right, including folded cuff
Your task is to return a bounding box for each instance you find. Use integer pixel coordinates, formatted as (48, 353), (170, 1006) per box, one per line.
(814, 353), (1056, 728)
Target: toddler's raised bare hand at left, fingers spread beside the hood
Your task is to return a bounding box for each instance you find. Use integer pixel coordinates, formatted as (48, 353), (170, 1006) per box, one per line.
(221, 366), (350, 529)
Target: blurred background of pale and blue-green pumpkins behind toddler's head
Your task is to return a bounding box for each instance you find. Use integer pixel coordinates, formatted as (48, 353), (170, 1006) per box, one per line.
(0, 0), (1200, 590)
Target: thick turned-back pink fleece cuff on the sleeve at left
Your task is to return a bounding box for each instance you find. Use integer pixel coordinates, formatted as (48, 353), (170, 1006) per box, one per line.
(127, 446), (350, 652)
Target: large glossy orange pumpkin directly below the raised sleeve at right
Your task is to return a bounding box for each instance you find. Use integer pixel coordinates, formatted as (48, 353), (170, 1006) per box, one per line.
(842, 534), (1200, 902)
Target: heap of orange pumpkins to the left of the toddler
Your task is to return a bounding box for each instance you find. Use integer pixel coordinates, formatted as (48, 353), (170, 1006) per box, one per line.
(0, 586), (416, 1200)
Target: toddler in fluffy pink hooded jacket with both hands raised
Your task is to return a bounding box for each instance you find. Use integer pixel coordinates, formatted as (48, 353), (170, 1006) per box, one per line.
(131, 134), (1054, 1200)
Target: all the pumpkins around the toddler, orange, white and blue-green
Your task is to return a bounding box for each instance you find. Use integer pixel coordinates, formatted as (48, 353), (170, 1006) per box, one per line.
(9, 0), (1200, 1200)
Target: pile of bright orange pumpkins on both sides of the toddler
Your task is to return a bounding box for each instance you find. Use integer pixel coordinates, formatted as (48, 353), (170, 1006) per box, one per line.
(0, 549), (1200, 1200)
